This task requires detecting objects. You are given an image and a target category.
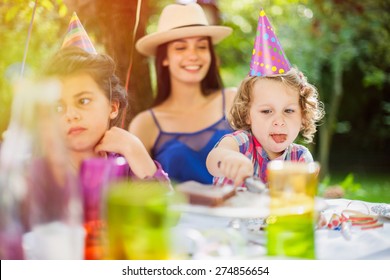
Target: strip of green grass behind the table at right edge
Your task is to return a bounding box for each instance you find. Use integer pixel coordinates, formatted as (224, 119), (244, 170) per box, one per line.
(319, 172), (390, 203)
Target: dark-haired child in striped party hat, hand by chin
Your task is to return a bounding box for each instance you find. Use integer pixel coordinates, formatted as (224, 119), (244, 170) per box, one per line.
(44, 15), (170, 187)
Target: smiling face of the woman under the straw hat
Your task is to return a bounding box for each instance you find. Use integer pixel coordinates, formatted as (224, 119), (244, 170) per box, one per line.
(163, 37), (211, 83)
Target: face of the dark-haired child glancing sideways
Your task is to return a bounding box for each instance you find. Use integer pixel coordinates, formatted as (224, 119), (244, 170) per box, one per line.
(57, 73), (118, 152)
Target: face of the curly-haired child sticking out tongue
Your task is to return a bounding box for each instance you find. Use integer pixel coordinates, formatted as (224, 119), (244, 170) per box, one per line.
(247, 79), (302, 159)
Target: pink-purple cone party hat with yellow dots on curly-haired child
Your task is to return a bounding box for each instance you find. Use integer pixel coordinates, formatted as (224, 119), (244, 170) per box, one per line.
(249, 9), (291, 76)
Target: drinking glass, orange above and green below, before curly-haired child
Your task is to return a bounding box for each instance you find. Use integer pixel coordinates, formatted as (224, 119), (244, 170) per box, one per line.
(266, 161), (319, 259)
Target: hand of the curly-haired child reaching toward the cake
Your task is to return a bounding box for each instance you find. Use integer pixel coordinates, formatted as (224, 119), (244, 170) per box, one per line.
(218, 152), (253, 186)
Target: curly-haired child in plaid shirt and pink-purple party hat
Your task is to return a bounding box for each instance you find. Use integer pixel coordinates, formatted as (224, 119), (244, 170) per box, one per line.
(206, 10), (324, 186)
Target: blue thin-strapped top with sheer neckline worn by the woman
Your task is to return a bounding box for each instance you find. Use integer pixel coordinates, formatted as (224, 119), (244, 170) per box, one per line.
(150, 90), (233, 184)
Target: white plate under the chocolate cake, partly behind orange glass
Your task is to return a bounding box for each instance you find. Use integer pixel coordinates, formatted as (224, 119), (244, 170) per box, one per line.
(171, 192), (328, 218)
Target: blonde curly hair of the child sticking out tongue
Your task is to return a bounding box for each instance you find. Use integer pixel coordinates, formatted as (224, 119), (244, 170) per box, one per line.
(228, 68), (325, 143)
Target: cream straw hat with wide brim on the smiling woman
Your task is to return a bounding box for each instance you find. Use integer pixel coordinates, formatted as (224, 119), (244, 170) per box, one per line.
(135, 3), (232, 56)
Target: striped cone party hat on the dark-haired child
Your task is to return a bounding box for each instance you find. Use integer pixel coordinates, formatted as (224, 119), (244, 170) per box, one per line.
(61, 12), (97, 54)
